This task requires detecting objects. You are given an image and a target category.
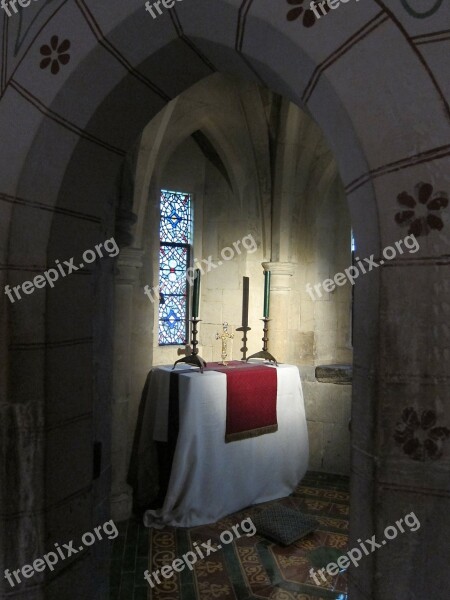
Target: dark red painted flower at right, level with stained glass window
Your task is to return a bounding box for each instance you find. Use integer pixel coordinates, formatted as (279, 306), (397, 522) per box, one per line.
(395, 182), (448, 237)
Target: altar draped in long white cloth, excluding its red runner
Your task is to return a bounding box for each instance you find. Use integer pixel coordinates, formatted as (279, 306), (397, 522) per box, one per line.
(139, 364), (308, 528)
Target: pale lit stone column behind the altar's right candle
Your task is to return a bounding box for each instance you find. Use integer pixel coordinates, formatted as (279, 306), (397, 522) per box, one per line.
(262, 262), (295, 362)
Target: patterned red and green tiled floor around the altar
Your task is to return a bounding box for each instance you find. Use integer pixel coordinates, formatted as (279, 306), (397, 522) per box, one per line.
(111, 472), (348, 600)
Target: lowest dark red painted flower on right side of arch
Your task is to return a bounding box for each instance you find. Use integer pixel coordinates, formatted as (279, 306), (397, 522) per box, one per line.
(394, 407), (450, 462)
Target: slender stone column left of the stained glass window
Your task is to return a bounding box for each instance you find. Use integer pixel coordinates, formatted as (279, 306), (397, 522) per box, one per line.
(111, 248), (143, 521)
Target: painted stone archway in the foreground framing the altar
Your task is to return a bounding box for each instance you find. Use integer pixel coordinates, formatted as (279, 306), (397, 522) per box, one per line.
(0, 0), (450, 600)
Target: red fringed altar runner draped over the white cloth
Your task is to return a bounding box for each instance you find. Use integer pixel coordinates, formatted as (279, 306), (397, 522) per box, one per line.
(207, 361), (278, 442)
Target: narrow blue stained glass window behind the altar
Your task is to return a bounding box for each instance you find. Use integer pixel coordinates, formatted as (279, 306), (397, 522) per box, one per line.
(158, 190), (192, 346)
